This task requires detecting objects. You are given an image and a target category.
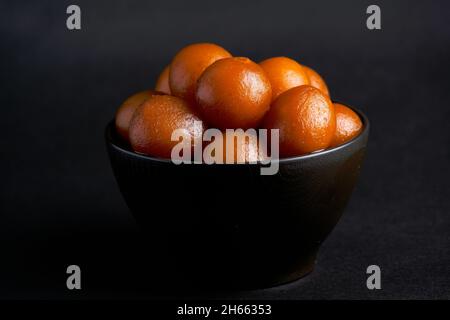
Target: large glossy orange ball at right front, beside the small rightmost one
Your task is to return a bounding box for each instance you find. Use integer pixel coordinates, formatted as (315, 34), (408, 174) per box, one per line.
(264, 85), (336, 157)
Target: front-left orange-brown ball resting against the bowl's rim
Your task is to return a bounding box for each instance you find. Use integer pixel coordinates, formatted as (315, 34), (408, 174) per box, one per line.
(129, 95), (205, 158)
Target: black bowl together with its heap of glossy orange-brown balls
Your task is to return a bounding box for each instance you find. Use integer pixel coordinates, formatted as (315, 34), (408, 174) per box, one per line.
(105, 42), (369, 288)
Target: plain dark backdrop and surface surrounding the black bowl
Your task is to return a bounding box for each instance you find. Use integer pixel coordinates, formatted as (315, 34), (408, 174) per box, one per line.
(0, 0), (450, 299)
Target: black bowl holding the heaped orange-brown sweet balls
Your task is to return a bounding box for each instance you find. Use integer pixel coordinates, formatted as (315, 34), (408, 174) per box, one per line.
(106, 105), (369, 288)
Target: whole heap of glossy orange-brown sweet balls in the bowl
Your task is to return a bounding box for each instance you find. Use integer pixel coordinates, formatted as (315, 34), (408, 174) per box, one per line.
(115, 43), (362, 163)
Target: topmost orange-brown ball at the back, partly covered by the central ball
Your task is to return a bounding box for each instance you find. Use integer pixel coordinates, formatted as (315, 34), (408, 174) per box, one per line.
(169, 43), (231, 104)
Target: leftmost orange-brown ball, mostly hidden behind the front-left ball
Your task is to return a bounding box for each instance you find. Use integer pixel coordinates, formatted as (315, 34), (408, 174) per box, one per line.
(115, 90), (162, 141)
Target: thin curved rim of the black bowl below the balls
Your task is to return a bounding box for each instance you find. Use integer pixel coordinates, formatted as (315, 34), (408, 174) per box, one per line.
(105, 101), (370, 166)
